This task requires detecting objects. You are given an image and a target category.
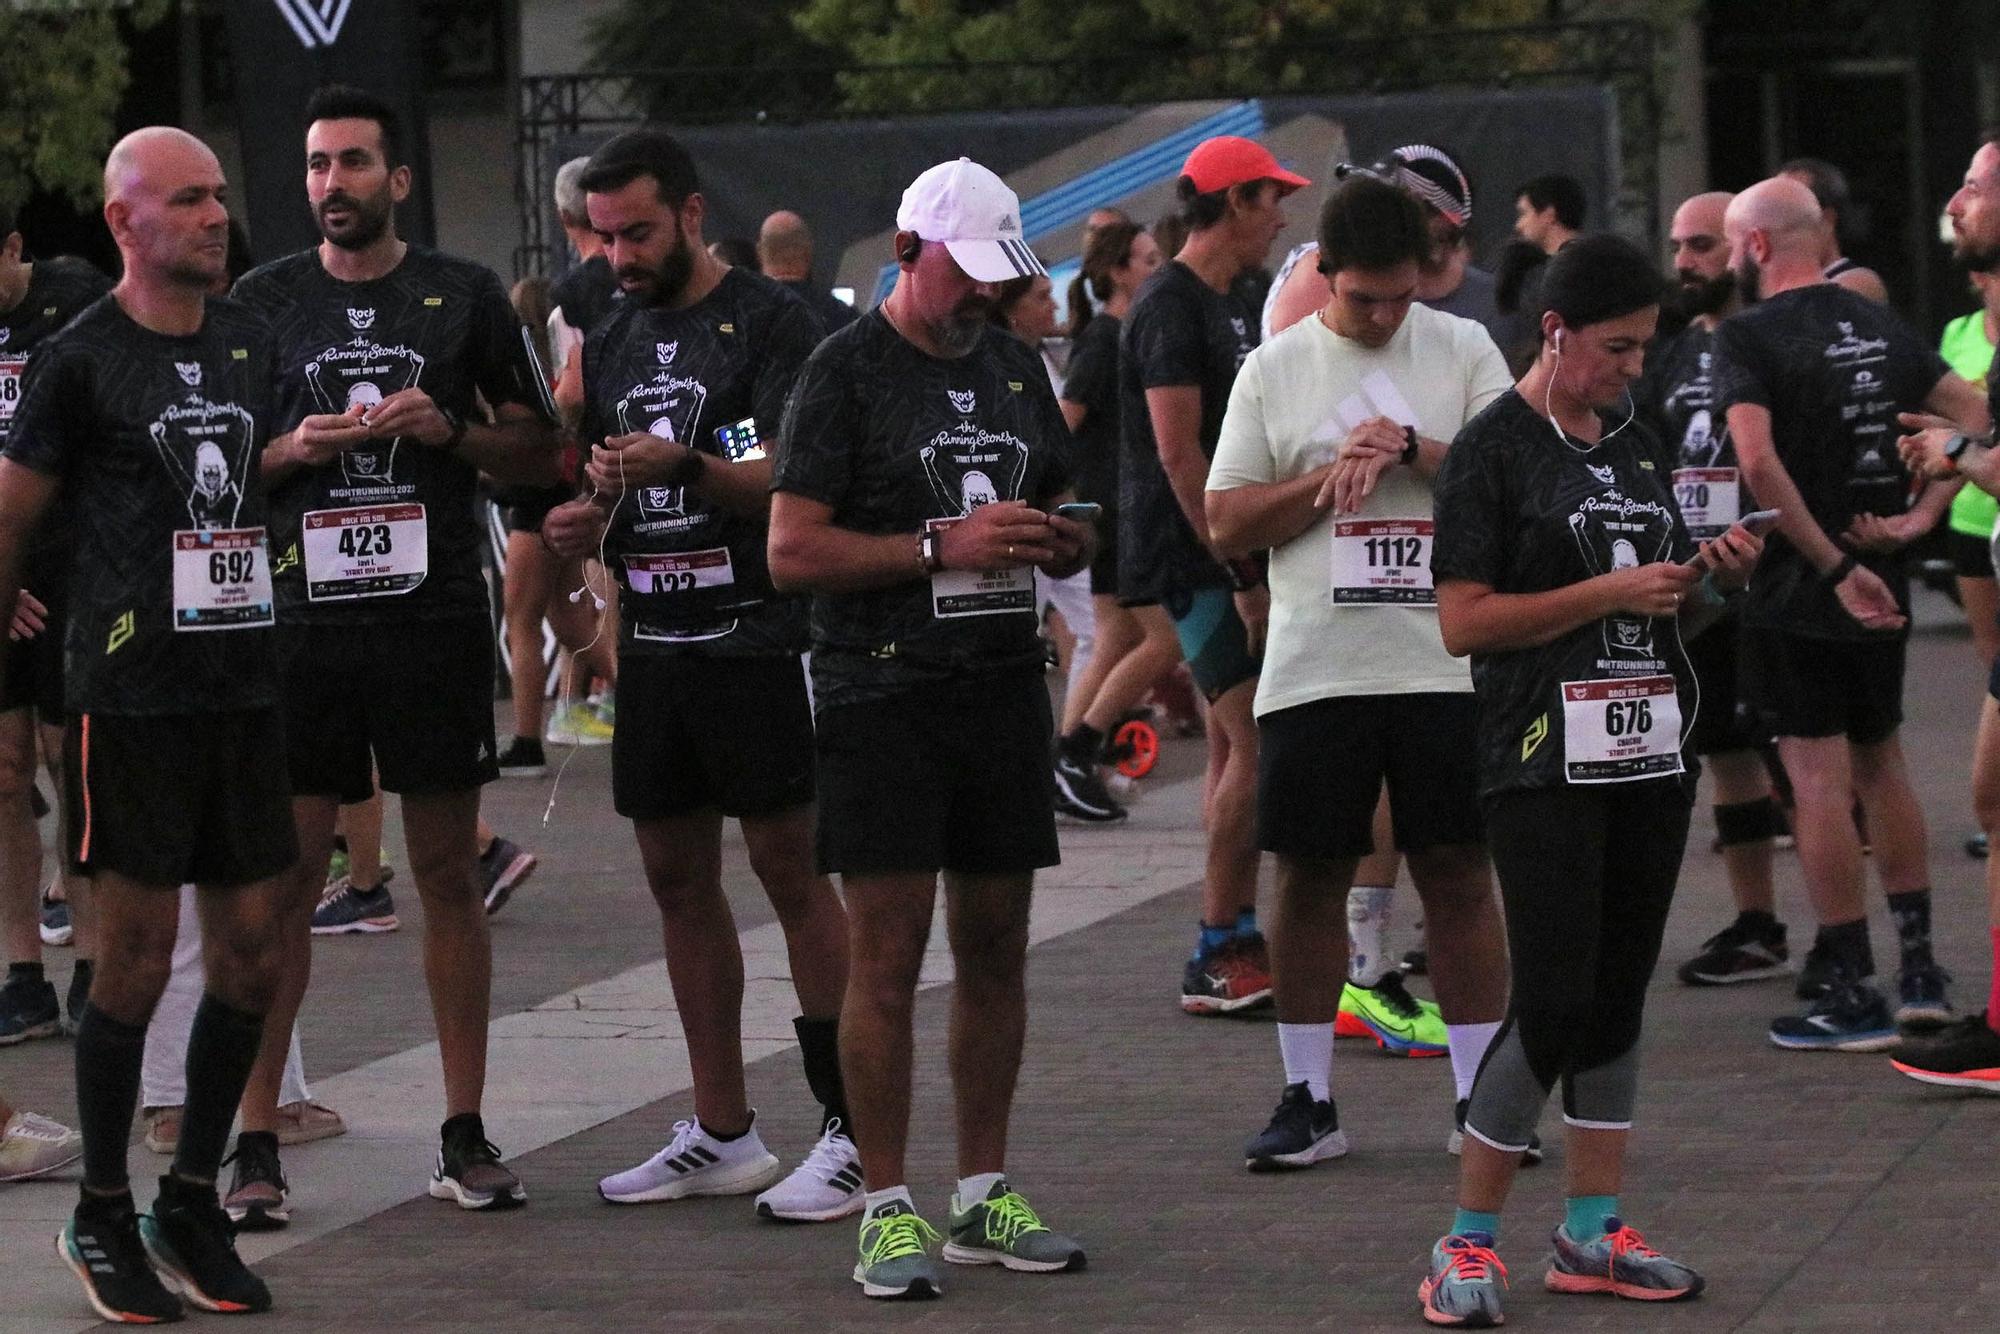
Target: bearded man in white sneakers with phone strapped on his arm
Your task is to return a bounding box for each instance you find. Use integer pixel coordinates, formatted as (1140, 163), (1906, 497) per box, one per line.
(542, 130), (862, 1222)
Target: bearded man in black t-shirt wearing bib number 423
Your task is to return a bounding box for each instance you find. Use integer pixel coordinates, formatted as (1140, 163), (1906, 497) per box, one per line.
(228, 88), (556, 1226)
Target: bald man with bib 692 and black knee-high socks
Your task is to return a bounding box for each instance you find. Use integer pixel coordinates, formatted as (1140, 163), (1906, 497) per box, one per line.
(0, 128), (298, 1322)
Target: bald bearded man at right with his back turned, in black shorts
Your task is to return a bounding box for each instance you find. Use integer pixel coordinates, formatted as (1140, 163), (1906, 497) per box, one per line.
(1714, 176), (1986, 1052)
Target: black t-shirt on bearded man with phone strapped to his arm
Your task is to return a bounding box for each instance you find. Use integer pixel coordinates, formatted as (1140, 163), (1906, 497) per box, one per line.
(582, 268), (820, 654)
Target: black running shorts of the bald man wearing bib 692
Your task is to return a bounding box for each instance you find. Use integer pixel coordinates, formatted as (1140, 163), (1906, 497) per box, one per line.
(62, 708), (298, 888)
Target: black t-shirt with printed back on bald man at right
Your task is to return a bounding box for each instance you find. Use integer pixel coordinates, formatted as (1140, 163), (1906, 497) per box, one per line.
(1714, 282), (1950, 640)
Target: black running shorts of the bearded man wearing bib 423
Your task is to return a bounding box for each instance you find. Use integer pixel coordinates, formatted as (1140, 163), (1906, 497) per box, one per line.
(278, 616), (500, 802)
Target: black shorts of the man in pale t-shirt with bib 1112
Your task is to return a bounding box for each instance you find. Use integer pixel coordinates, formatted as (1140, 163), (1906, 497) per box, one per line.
(1256, 690), (1486, 860)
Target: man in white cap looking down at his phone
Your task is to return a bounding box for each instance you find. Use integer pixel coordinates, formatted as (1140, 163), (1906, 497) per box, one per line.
(770, 158), (1096, 1298)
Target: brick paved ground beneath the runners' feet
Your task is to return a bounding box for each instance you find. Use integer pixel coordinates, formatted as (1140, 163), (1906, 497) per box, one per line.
(0, 588), (2000, 1330)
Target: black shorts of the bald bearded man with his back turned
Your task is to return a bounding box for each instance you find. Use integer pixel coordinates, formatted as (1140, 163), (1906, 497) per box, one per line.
(1742, 630), (1908, 746)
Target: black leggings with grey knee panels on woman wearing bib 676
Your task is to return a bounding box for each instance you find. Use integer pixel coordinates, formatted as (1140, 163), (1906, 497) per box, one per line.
(1466, 778), (1690, 1150)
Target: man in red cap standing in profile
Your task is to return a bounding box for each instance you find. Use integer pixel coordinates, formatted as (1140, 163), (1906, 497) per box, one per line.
(1118, 136), (1312, 1014)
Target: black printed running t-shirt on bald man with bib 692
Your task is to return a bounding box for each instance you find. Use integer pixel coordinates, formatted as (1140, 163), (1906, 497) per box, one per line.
(6, 296), (278, 714)
